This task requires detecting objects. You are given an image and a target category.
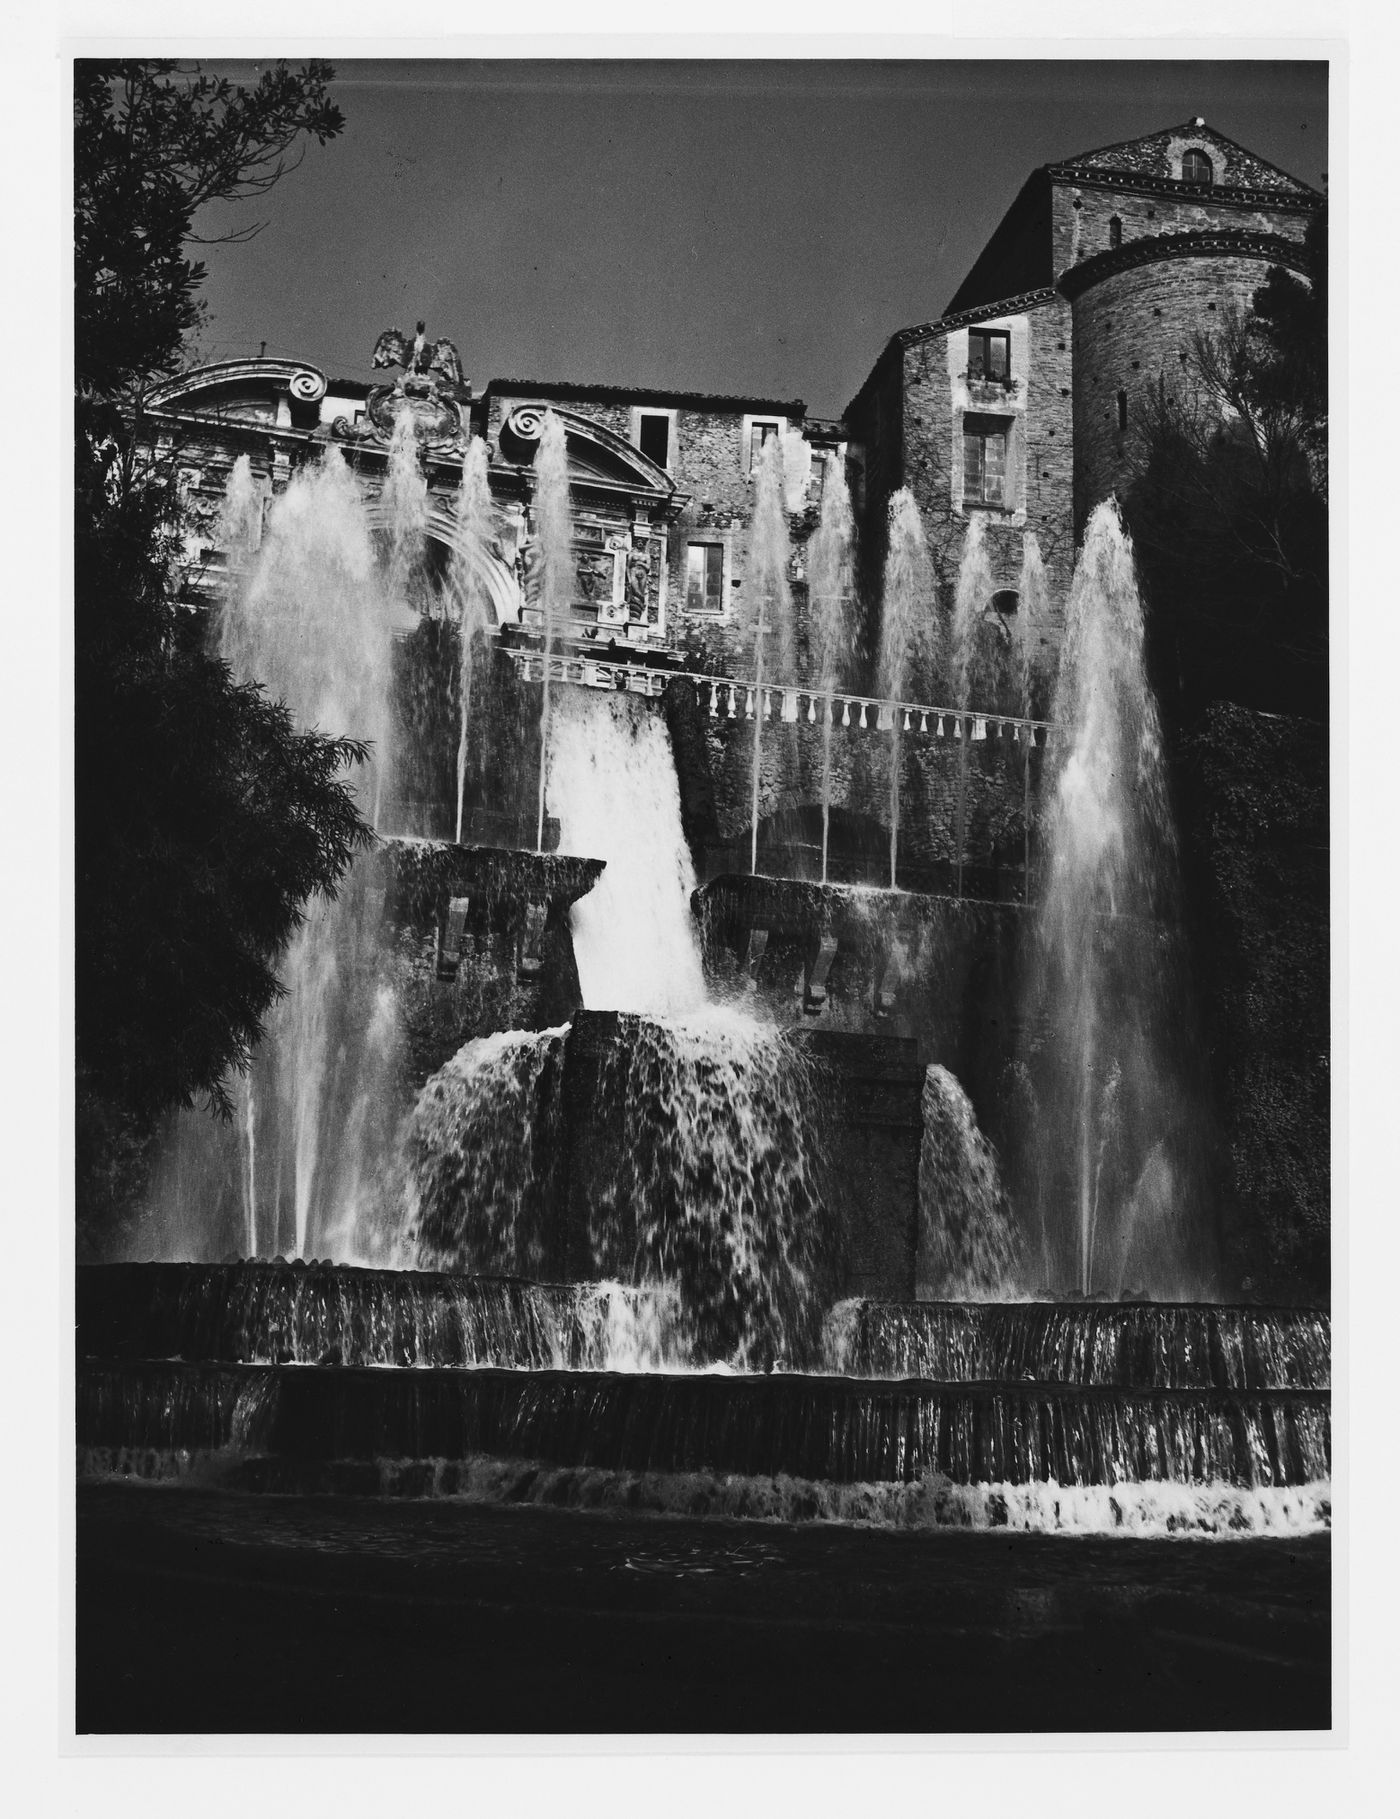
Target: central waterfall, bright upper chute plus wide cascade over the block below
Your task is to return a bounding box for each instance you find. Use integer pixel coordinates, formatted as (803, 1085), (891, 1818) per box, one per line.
(405, 689), (831, 1364)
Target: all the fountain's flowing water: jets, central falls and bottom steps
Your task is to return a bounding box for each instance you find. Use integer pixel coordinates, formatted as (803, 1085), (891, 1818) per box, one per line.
(78, 405), (1331, 1537)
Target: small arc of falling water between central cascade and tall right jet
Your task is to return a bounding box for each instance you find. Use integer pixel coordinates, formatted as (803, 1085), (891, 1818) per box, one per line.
(915, 1066), (1018, 1301)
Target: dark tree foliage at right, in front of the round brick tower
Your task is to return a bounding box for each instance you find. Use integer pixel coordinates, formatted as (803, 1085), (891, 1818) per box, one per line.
(1124, 218), (1327, 722)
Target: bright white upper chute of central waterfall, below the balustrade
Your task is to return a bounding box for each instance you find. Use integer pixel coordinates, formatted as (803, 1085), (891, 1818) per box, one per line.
(549, 689), (705, 1017)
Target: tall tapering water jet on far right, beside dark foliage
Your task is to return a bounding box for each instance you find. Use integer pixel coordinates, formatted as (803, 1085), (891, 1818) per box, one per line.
(1038, 502), (1184, 1295)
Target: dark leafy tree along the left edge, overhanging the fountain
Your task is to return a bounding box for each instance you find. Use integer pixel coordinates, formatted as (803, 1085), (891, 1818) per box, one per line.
(75, 62), (363, 1164)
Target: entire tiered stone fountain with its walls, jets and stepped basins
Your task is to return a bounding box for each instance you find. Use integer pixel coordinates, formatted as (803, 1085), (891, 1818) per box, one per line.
(78, 422), (1331, 1537)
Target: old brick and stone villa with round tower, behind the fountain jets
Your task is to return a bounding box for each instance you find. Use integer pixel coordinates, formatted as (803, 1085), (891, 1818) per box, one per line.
(151, 118), (1324, 716)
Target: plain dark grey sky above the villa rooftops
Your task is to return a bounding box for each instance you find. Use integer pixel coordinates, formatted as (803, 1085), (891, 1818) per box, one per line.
(190, 62), (1327, 415)
